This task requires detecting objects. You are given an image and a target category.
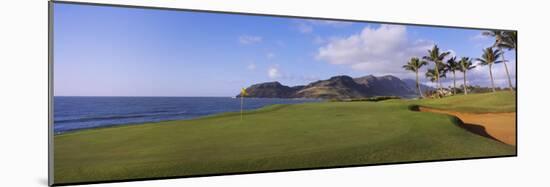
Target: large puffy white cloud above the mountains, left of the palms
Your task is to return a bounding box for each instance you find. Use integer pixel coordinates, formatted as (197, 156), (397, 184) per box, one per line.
(316, 24), (434, 76)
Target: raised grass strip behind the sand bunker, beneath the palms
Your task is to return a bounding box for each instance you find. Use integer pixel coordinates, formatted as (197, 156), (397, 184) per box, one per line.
(416, 91), (516, 113)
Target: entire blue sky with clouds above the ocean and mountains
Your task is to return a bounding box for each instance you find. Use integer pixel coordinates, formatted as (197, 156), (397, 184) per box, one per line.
(54, 4), (515, 96)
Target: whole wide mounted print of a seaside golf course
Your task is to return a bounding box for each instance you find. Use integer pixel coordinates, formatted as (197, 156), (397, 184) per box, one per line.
(49, 2), (517, 185)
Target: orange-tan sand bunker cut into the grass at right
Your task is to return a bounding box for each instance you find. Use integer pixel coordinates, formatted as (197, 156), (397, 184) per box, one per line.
(419, 107), (516, 146)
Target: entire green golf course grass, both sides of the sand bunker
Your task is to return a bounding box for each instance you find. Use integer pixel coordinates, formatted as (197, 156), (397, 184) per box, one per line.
(54, 92), (516, 183)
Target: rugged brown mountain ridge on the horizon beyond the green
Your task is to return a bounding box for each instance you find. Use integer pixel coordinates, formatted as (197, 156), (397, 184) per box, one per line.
(237, 75), (424, 99)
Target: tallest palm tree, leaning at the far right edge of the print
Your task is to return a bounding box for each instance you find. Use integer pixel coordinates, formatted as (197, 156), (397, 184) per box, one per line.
(483, 30), (516, 91)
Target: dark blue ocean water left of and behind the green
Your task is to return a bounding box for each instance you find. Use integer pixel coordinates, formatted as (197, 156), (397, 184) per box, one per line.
(53, 96), (320, 133)
